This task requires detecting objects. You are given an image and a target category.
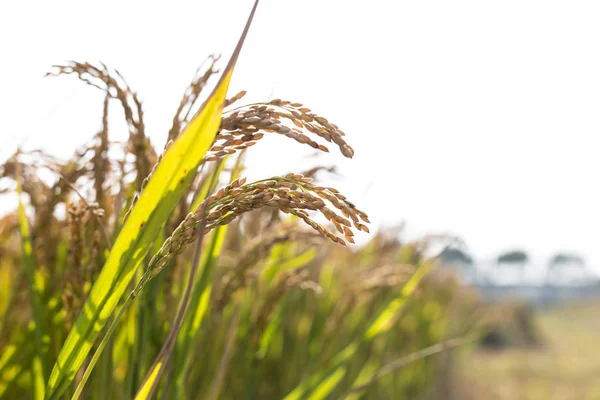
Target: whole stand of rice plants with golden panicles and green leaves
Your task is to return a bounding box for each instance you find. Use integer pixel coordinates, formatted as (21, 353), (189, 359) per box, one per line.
(0, 4), (476, 399)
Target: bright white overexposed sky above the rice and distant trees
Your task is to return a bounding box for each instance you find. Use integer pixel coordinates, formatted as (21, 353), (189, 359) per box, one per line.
(0, 0), (600, 265)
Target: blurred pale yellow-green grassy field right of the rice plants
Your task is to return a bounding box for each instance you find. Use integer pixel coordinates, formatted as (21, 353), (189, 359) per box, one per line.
(452, 301), (600, 400)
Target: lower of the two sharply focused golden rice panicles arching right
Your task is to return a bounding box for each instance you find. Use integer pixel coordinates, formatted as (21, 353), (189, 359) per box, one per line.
(148, 174), (369, 282)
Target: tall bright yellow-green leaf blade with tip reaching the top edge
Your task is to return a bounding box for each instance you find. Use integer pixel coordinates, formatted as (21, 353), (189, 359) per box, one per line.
(46, 1), (258, 399)
